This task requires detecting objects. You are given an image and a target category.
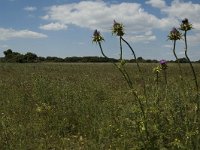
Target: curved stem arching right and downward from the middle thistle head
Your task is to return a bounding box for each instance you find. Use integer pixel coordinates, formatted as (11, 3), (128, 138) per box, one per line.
(121, 37), (146, 96)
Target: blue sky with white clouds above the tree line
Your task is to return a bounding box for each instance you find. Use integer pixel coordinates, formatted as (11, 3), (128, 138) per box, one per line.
(0, 0), (200, 60)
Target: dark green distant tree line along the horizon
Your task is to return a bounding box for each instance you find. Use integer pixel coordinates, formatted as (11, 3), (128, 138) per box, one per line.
(0, 49), (200, 63)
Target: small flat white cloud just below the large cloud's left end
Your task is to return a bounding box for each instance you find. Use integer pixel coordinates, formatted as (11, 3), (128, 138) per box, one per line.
(39, 23), (67, 31)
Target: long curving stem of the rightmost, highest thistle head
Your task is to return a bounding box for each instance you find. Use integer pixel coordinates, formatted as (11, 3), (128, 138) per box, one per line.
(184, 31), (199, 97)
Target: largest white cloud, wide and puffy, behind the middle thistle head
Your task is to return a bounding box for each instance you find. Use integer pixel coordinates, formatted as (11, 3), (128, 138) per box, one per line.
(42, 1), (168, 41)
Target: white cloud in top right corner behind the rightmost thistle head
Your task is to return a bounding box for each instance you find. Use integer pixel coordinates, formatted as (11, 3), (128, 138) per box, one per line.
(146, 0), (200, 30)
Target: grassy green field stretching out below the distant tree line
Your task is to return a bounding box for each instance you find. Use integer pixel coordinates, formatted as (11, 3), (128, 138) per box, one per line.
(0, 63), (200, 150)
